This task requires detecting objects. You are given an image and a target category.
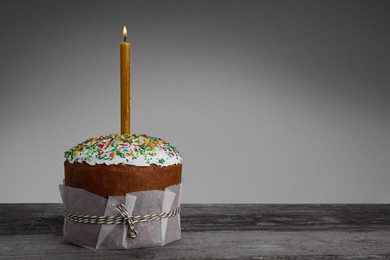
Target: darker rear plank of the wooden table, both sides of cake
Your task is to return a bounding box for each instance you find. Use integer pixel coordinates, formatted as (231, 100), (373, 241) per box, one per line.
(0, 204), (390, 236)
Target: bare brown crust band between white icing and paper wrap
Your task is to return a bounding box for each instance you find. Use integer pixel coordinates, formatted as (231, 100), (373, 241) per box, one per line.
(64, 161), (182, 198)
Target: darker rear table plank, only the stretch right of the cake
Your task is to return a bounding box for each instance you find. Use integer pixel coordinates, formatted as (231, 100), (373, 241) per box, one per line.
(182, 204), (390, 231)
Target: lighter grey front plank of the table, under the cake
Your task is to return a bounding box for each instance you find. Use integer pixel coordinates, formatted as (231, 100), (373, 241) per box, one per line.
(0, 231), (390, 259)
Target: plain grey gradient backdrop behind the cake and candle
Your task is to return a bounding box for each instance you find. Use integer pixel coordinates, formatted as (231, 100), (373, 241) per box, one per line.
(0, 0), (390, 203)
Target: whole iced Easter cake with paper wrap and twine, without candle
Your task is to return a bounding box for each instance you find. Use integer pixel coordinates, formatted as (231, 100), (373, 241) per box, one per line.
(60, 134), (183, 250)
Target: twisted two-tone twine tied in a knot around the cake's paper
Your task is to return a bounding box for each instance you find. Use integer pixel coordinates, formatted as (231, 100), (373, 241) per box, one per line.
(64, 203), (181, 238)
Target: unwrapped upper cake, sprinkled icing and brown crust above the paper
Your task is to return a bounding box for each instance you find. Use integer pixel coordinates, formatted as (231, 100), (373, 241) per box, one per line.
(64, 134), (182, 198)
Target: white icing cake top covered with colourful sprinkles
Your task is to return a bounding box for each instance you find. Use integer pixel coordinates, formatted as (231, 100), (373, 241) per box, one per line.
(65, 134), (183, 166)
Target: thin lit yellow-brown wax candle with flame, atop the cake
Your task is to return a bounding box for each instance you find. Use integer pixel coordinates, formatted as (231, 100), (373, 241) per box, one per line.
(120, 26), (131, 134)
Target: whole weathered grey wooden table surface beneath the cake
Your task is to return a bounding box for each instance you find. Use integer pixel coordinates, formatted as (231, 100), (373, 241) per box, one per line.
(0, 204), (390, 259)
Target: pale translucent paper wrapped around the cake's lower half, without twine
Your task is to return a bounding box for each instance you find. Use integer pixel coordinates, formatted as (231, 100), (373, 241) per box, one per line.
(60, 184), (181, 250)
